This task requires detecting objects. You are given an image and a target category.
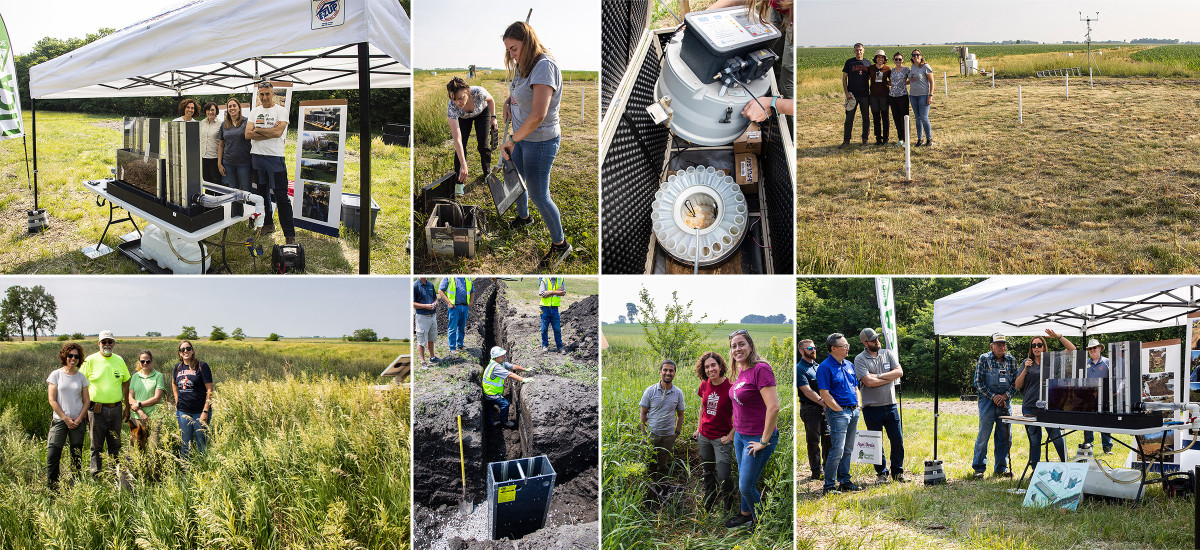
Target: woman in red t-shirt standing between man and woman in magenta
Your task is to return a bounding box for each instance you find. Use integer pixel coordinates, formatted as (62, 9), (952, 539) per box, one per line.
(692, 352), (733, 509)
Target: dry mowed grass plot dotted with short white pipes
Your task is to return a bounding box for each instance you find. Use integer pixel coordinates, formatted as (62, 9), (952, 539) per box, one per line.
(797, 48), (1200, 273)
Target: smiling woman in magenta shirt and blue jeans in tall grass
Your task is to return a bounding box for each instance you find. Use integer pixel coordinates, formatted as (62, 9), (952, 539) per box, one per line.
(725, 329), (779, 528)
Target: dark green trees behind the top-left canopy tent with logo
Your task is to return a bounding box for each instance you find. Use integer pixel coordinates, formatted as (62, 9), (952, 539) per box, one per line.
(13, 24), (412, 134)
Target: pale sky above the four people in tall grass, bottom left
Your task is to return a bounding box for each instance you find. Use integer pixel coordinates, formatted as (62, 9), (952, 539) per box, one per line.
(0, 275), (413, 339)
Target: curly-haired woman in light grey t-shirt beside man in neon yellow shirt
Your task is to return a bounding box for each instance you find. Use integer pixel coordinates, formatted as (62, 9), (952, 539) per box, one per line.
(46, 342), (91, 491)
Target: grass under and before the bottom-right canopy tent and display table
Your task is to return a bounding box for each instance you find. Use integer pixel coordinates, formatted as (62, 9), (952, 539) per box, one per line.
(796, 397), (1193, 549)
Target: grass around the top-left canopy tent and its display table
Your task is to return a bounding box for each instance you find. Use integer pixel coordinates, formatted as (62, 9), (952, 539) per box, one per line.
(0, 112), (412, 274)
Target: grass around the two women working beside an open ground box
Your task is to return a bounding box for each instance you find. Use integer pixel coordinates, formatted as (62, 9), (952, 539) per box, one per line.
(413, 71), (600, 274)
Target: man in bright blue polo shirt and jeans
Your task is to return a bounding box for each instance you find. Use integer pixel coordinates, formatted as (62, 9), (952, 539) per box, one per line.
(817, 333), (862, 495)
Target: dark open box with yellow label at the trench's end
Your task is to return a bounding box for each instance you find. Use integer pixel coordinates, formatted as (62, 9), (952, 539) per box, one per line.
(487, 455), (556, 540)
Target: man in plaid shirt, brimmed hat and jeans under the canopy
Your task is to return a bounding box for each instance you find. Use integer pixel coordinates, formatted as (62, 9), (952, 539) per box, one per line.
(971, 333), (1019, 479)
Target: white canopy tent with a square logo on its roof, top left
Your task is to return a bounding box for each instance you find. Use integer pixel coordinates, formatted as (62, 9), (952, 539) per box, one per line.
(29, 0), (413, 273)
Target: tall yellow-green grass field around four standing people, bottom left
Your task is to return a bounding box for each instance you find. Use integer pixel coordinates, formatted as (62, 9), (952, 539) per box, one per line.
(0, 337), (410, 549)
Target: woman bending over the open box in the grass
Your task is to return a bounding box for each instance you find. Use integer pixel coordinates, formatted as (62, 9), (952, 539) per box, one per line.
(446, 77), (499, 195)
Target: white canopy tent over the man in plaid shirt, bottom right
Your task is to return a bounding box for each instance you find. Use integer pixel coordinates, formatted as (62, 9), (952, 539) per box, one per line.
(934, 275), (1200, 460)
